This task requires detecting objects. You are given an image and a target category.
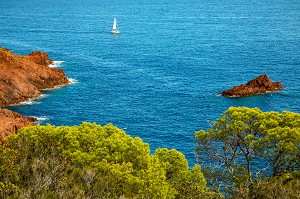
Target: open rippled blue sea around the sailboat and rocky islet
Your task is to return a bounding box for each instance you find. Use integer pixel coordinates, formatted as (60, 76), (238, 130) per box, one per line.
(0, 0), (300, 165)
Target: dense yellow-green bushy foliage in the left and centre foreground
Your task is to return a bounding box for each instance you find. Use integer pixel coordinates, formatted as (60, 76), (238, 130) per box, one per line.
(0, 123), (220, 199)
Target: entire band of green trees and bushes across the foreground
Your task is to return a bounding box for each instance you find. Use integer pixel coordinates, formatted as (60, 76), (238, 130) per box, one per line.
(0, 107), (300, 199)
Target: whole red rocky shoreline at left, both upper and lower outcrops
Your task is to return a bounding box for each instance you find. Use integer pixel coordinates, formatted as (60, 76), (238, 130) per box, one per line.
(0, 47), (70, 141)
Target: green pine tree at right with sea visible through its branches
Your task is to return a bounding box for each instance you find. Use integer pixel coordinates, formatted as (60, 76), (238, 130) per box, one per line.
(195, 107), (300, 198)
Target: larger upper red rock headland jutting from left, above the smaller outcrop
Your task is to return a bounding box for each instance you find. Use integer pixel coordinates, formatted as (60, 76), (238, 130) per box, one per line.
(0, 48), (69, 107)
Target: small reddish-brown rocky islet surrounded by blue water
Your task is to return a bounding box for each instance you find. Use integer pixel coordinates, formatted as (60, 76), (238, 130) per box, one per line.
(221, 75), (283, 97)
